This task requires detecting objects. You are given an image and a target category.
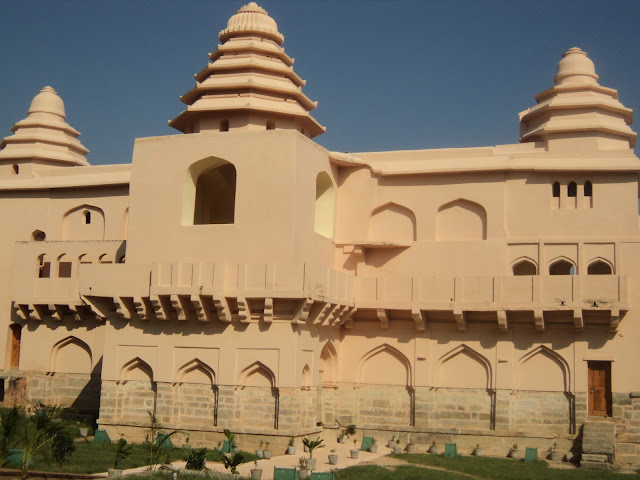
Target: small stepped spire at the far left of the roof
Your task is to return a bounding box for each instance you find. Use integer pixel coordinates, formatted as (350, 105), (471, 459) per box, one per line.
(0, 87), (89, 165)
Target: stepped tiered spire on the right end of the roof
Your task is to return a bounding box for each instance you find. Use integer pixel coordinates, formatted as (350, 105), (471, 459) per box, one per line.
(520, 47), (637, 150)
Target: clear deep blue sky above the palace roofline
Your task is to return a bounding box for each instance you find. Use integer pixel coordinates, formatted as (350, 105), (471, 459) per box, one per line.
(0, 0), (640, 165)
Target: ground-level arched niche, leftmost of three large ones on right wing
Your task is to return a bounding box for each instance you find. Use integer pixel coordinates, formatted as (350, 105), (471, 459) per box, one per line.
(356, 343), (415, 428)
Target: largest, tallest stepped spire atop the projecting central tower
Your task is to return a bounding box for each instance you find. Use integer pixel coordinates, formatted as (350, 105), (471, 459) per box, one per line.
(169, 2), (325, 138)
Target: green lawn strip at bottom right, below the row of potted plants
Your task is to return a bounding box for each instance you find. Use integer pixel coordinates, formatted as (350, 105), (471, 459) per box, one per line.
(391, 453), (640, 480)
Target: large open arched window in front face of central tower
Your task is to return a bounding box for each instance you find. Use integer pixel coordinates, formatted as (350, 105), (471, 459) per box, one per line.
(182, 157), (236, 225)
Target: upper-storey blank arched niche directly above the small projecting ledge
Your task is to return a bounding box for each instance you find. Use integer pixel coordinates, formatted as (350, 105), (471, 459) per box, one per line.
(369, 202), (416, 242)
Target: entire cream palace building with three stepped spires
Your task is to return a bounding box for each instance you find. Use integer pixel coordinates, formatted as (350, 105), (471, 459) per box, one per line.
(0, 2), (640, 464)
